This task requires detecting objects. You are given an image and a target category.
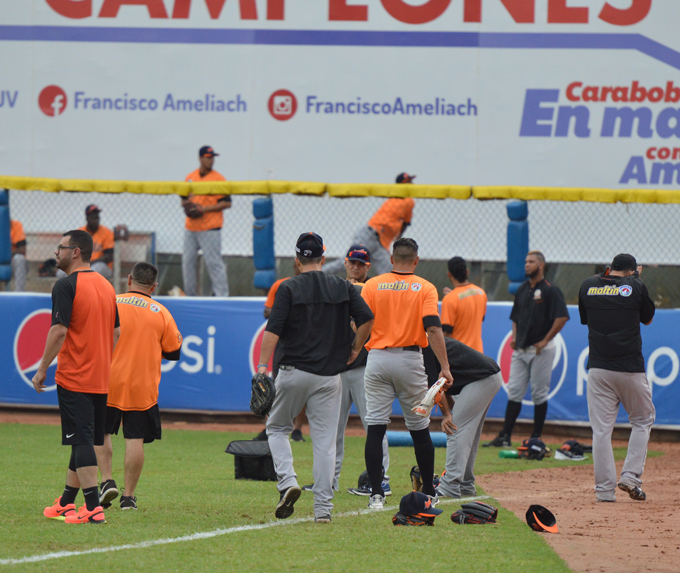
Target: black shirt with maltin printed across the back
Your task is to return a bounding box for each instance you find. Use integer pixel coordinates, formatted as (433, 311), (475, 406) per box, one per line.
(578, 275), (655, 372)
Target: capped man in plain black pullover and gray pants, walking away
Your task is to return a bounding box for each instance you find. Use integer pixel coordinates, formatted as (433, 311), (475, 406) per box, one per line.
(258, 233), (373, 523)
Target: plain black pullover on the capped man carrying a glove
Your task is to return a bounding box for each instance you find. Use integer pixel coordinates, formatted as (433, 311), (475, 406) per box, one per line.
(266, 271), (373, 376)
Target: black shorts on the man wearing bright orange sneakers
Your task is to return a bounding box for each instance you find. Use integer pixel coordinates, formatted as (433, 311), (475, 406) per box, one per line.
(57, 385), (108, 446)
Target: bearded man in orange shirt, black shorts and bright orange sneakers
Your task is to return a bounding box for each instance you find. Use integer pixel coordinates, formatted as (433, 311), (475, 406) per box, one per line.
(33, 229), (120, 523)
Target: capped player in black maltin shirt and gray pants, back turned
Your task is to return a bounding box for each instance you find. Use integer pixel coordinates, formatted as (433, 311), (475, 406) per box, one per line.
(578, 254), (656, 501)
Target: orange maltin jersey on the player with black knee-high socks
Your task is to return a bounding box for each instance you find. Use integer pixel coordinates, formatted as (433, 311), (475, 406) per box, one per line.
(361, 271), (439, 350)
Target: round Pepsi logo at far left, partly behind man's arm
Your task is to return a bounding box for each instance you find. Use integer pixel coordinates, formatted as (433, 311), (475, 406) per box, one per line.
(14, 308), (57, 392)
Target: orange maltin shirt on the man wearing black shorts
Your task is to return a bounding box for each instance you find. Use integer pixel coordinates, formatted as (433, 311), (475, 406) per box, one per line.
(107, 291), (182, 410)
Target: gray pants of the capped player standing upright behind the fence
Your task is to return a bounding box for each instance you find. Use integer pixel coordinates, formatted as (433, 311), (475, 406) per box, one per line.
(182, 229), (229, 296)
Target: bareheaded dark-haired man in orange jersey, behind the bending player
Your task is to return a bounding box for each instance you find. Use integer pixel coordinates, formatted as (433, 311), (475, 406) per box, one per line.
(442, 257), (486, 352)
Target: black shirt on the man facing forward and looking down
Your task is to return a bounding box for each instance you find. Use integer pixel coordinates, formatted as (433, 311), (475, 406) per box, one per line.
(510, 279), (569, 348)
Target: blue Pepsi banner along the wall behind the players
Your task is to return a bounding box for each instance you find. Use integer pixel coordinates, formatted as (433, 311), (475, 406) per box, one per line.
(0, 294), (680, 426)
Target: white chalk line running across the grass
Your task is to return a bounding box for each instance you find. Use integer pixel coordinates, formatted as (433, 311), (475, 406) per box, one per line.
(0, 495), (490, 565)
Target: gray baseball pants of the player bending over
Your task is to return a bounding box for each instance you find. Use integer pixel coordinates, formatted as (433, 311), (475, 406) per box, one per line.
(439, 372), (503, 497)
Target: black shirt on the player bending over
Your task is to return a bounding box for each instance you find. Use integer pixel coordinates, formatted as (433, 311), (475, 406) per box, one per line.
(423, 338), (501, 396)
